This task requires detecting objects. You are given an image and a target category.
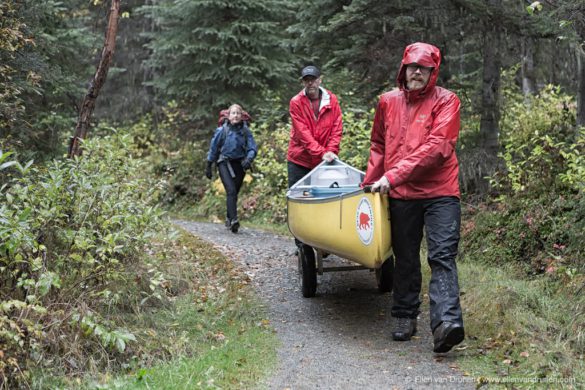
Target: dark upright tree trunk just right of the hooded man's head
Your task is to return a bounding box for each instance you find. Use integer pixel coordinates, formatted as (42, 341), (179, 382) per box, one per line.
(479, 0), (501, 157)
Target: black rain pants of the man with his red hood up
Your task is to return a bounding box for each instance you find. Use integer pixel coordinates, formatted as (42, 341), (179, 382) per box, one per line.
(390, 196), (463, 330)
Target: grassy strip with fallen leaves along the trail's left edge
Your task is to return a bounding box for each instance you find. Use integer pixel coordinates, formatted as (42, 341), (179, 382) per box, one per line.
(63, 230), (278, 389)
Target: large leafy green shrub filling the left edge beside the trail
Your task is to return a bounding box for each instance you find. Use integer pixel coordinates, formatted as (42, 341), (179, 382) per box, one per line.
(0, 133), (169, 387)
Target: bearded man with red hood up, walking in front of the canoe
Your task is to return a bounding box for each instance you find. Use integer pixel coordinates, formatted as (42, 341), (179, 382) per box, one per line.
(364, 42), (465, 353)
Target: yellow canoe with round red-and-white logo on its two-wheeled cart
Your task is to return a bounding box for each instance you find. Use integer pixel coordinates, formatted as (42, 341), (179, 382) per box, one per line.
(286, 159), (394, 298)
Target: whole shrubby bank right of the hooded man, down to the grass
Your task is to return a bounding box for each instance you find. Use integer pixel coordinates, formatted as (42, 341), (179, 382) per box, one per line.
(463, 82), (585, 278)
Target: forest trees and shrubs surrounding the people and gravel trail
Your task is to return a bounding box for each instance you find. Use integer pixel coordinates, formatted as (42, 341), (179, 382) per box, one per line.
(0, 0), (585, 388)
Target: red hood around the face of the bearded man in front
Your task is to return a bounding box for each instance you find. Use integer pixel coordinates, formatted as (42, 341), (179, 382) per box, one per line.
(396, 42), (441, 96)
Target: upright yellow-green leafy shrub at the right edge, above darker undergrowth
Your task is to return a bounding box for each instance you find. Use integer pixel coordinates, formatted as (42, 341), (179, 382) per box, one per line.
(493, 85), (585, 196)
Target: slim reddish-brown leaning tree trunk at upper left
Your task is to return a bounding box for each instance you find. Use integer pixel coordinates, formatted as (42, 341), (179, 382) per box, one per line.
(69, 0), (120, 158)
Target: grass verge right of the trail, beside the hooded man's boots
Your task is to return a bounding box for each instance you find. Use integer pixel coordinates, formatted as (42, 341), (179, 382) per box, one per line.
(442, 260), (585, 389)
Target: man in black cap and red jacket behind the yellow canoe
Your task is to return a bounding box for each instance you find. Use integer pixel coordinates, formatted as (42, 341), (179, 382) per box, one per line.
(287, 65), (343, 258)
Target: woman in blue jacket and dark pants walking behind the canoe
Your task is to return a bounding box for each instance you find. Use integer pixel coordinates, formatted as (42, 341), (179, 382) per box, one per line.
(205, 104), (257, 233)
